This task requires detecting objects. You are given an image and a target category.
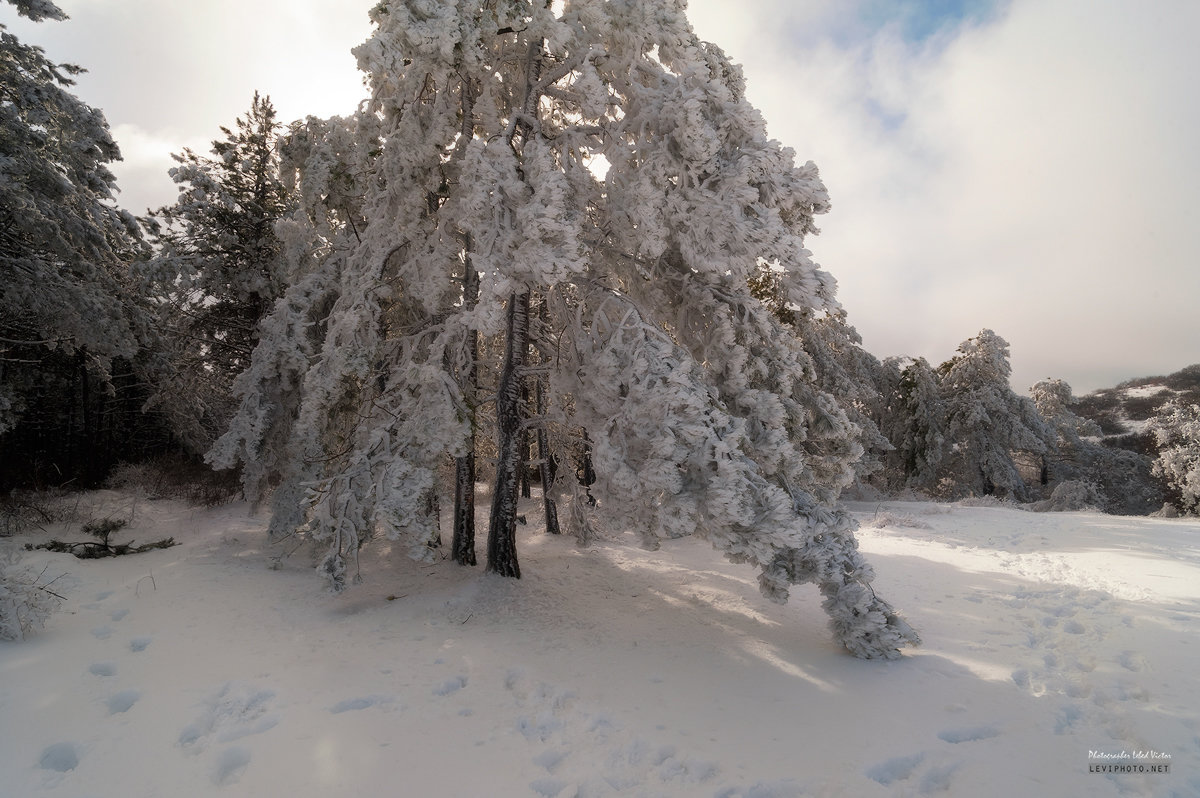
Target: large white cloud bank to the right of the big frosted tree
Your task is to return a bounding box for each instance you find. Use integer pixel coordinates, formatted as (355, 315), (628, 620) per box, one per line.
(691, 0), (1200, 392)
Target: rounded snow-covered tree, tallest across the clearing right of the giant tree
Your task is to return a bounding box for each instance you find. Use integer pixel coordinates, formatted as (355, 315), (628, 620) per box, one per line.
(938, 330), (1054, 500)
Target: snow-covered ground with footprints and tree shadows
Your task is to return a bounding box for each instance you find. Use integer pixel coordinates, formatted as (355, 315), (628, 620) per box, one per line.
(0, 492), (1200, 798)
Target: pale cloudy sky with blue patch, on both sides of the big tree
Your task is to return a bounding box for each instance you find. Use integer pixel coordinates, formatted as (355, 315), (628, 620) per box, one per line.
(0, 0), (1200, 395)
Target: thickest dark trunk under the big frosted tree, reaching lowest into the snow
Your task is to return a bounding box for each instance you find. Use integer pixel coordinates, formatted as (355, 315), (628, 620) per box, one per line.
(487, 292), (529, 578)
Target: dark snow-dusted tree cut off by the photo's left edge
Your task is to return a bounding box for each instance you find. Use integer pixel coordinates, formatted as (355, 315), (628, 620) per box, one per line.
(0, 0), (157, 481)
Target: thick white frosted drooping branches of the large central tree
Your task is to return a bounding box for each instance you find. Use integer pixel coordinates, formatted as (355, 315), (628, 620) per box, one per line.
(210, 0), (918, 658)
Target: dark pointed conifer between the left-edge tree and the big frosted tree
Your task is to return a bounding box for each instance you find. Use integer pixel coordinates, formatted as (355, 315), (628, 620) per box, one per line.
(140, 92), (294, 452)
